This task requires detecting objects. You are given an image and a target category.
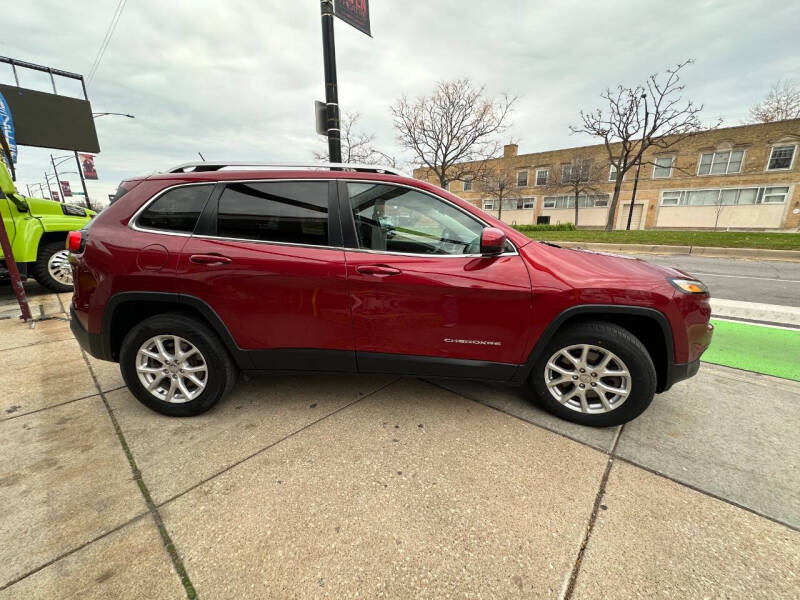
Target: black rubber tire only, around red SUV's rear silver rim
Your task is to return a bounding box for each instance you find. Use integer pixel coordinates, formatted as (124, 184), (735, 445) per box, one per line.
(119, 313), (237, 417)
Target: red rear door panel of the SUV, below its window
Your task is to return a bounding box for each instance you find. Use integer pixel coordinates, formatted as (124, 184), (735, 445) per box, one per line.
(176, 238), (353, 350)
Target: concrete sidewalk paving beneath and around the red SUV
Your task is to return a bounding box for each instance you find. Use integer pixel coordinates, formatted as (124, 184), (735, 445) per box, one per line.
(0, 288), (800, 600)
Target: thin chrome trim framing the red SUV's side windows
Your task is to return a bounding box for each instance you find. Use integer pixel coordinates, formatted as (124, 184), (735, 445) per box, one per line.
(128, 177), (519, 258)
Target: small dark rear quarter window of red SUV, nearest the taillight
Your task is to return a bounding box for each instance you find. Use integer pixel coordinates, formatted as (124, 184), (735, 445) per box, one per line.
(136, 184), (214, 233)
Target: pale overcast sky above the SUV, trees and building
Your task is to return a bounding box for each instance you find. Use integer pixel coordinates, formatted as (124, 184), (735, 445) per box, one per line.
(0, 0), (800, 204)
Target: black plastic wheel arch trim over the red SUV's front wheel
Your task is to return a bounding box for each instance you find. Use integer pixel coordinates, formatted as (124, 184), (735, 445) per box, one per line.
(512, 304), (675, 392)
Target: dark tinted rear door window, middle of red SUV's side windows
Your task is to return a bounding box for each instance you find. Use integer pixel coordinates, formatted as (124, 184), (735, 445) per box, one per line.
(217, 181), (330, 246)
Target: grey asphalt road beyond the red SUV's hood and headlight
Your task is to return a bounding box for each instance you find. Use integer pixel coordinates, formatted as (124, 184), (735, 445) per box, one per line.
(638, 255), (800, 306)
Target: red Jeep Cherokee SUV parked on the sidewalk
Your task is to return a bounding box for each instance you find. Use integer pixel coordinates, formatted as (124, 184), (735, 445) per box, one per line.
(68, 163), (712, 426)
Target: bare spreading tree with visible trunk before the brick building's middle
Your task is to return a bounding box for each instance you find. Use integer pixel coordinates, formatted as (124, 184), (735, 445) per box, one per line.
(570, 59), (722, 231)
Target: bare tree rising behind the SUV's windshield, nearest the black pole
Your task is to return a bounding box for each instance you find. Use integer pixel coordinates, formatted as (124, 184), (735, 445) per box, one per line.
(391, 79), (517, 188)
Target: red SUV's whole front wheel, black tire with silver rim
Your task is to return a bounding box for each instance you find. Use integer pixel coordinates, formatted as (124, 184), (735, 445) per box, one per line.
(529, 322), (657, 427)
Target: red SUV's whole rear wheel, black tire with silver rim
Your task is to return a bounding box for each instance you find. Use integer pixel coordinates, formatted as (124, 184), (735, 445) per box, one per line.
(120, 313), (236, 417)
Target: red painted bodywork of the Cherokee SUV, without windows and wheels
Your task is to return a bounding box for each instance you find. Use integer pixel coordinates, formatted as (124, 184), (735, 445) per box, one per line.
(71, 170), (712, 386)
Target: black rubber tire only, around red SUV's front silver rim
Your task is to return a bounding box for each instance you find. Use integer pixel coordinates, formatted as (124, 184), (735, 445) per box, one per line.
(528, 322), (657, 427)
